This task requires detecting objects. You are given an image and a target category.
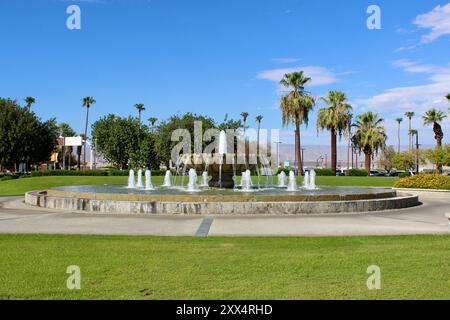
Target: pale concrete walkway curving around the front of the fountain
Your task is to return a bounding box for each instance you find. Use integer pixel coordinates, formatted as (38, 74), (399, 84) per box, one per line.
(0, 192), (450, 237)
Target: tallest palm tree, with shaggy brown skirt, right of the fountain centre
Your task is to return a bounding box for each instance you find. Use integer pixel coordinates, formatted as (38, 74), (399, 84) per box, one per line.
(280, 71), (316, 175)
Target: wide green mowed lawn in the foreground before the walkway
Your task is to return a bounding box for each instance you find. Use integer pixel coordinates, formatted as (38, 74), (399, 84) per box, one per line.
(0, 235), (450, 299)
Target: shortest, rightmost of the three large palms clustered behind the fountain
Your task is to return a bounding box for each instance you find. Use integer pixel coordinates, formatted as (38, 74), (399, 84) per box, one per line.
(352, 112), (387, 173)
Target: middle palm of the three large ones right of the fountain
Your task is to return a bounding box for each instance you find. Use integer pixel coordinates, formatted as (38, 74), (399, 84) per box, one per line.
(317, 91), (352, 175)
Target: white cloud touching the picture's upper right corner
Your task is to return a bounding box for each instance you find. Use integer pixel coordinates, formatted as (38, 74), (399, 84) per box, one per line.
(413, 3), (450, 43)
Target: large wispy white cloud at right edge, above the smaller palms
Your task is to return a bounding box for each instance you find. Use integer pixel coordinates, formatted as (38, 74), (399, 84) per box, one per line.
(353, 60), (450, 114)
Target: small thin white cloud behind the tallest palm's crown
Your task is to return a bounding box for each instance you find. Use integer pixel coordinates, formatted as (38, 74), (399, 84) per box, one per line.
(257, 66), (339, 87)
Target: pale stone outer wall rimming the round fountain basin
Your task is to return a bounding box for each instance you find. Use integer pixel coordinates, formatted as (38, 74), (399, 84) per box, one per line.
(25, 191), (420, 215)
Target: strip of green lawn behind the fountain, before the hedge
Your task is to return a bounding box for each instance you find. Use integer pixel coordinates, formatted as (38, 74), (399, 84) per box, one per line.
(0, 176), (398, 196)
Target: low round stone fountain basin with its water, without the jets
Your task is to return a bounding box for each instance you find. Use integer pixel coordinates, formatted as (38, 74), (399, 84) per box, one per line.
(25, 185), (419, 214)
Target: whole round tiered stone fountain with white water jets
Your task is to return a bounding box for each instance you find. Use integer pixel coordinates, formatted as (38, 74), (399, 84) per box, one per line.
(25, 127), (418, 214)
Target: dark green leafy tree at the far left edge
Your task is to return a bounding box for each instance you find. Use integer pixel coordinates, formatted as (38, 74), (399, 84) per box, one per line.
(0, 99), (58, 171)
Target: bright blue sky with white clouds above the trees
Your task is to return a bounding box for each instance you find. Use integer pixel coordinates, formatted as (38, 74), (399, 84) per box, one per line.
(0, 0), (450, 145)
